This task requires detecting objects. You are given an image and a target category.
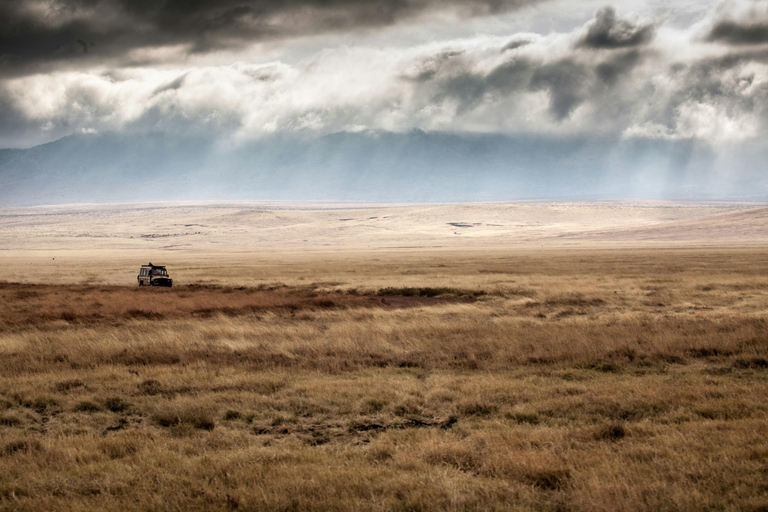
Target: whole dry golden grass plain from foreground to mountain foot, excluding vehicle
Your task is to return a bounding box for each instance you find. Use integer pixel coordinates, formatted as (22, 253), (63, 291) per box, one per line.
(0, 204), (768, 511)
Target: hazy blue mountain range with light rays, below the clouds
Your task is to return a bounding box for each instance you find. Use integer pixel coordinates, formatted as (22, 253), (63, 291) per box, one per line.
(0, 131), (768, 206)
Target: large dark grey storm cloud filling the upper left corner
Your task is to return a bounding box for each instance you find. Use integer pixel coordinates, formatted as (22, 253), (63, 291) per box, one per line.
(0, 0), (545, 74)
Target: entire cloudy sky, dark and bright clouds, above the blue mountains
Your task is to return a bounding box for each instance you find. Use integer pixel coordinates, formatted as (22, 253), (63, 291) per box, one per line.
(0, 0), (768, 148)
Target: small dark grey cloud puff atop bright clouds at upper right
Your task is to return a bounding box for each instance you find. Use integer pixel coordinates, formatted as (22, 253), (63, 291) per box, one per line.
(579, 7), (656, 49)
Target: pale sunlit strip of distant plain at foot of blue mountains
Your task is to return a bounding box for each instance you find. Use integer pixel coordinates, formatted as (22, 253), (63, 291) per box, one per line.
(0, 201), (768, 257)
